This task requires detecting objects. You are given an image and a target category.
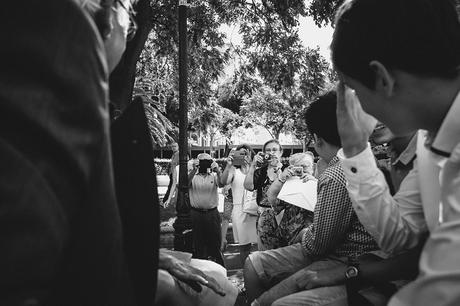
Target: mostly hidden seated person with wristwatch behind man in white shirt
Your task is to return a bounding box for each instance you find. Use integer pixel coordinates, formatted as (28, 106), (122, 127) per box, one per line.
(292, 125), (423, 305)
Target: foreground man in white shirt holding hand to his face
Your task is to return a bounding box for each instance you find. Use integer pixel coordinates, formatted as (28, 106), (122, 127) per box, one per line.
(331, 0), (460, 305)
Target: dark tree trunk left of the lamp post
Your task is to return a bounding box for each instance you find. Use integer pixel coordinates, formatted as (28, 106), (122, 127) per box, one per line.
(110, 0), (153, 111)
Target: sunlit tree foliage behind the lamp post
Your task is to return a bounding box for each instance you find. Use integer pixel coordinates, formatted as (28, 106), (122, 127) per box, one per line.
(124, 0), (339, 147)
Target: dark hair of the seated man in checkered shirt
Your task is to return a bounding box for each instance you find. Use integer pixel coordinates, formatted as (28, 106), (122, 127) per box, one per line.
(305, 91), (342, 148)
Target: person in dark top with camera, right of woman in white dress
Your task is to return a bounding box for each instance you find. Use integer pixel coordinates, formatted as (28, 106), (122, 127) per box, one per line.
(244, 139), (283, 251)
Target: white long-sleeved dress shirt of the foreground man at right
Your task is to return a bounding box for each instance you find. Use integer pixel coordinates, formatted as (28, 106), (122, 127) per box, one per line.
(338, 91), (460, 305)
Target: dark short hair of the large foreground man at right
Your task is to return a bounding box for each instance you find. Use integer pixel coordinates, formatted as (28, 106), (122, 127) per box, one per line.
(331, 0), (460, 89)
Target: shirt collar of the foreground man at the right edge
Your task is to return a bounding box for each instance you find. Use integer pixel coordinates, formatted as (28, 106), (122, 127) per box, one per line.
(431, 92), (460, 157)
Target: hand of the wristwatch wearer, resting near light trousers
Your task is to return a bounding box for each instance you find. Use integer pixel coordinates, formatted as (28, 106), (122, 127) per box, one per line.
(296, 262), (347, 290)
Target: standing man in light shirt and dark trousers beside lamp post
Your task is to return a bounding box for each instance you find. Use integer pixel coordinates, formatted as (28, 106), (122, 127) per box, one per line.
(188, 153), (224, 266)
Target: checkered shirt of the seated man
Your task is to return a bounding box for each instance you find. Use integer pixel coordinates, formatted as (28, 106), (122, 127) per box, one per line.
(302, 156), (378, 257)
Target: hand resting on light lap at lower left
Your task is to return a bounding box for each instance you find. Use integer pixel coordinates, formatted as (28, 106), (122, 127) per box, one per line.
(159, 250), (225, 296)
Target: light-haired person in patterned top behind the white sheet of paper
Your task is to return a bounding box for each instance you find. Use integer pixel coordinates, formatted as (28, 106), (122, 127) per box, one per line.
(267, 153), (316, 247)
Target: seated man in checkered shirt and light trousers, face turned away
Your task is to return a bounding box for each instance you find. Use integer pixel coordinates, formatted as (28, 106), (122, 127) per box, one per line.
(244, 92), (378, 305)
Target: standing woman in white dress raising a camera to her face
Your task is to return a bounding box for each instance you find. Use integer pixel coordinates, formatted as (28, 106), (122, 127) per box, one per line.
(221, 144), (257, 244)
